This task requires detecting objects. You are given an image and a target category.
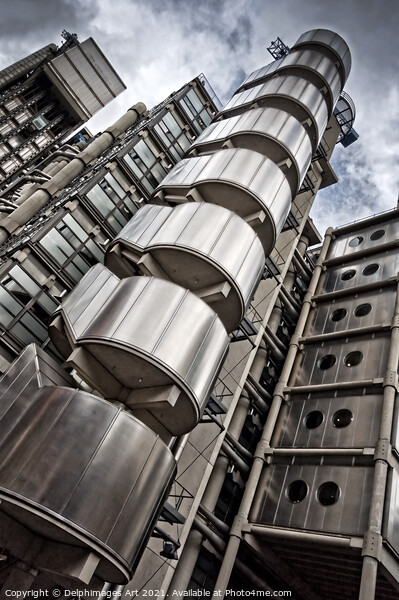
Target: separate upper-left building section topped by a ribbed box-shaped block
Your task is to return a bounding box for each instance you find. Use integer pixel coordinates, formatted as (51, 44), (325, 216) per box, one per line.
(0, 31), (126, 185)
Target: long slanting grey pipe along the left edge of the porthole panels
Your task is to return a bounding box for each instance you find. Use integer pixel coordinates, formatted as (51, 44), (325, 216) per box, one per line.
(215, 229), (332, 597)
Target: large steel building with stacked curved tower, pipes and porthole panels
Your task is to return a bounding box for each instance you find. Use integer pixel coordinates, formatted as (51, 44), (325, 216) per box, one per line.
(0, 25), (399, 600)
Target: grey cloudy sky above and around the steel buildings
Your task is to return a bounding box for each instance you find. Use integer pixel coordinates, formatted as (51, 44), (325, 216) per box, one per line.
(0, 0), (399, 232)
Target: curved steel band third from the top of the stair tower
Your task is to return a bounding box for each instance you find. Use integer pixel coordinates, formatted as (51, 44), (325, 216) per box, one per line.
(220, 74), (328, 151)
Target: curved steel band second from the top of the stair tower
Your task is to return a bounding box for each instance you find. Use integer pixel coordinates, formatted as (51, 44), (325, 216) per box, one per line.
(237, 49), (343, 114)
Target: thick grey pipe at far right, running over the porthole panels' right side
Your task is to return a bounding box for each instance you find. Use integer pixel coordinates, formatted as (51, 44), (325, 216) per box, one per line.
(359, 284), (399, 600)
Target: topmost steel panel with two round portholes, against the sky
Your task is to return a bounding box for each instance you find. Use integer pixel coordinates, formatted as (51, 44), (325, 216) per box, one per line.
(328, 219), (399, 258)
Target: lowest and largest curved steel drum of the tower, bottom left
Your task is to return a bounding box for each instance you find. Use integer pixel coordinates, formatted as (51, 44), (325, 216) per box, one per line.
(0, 356), (176, 584)
